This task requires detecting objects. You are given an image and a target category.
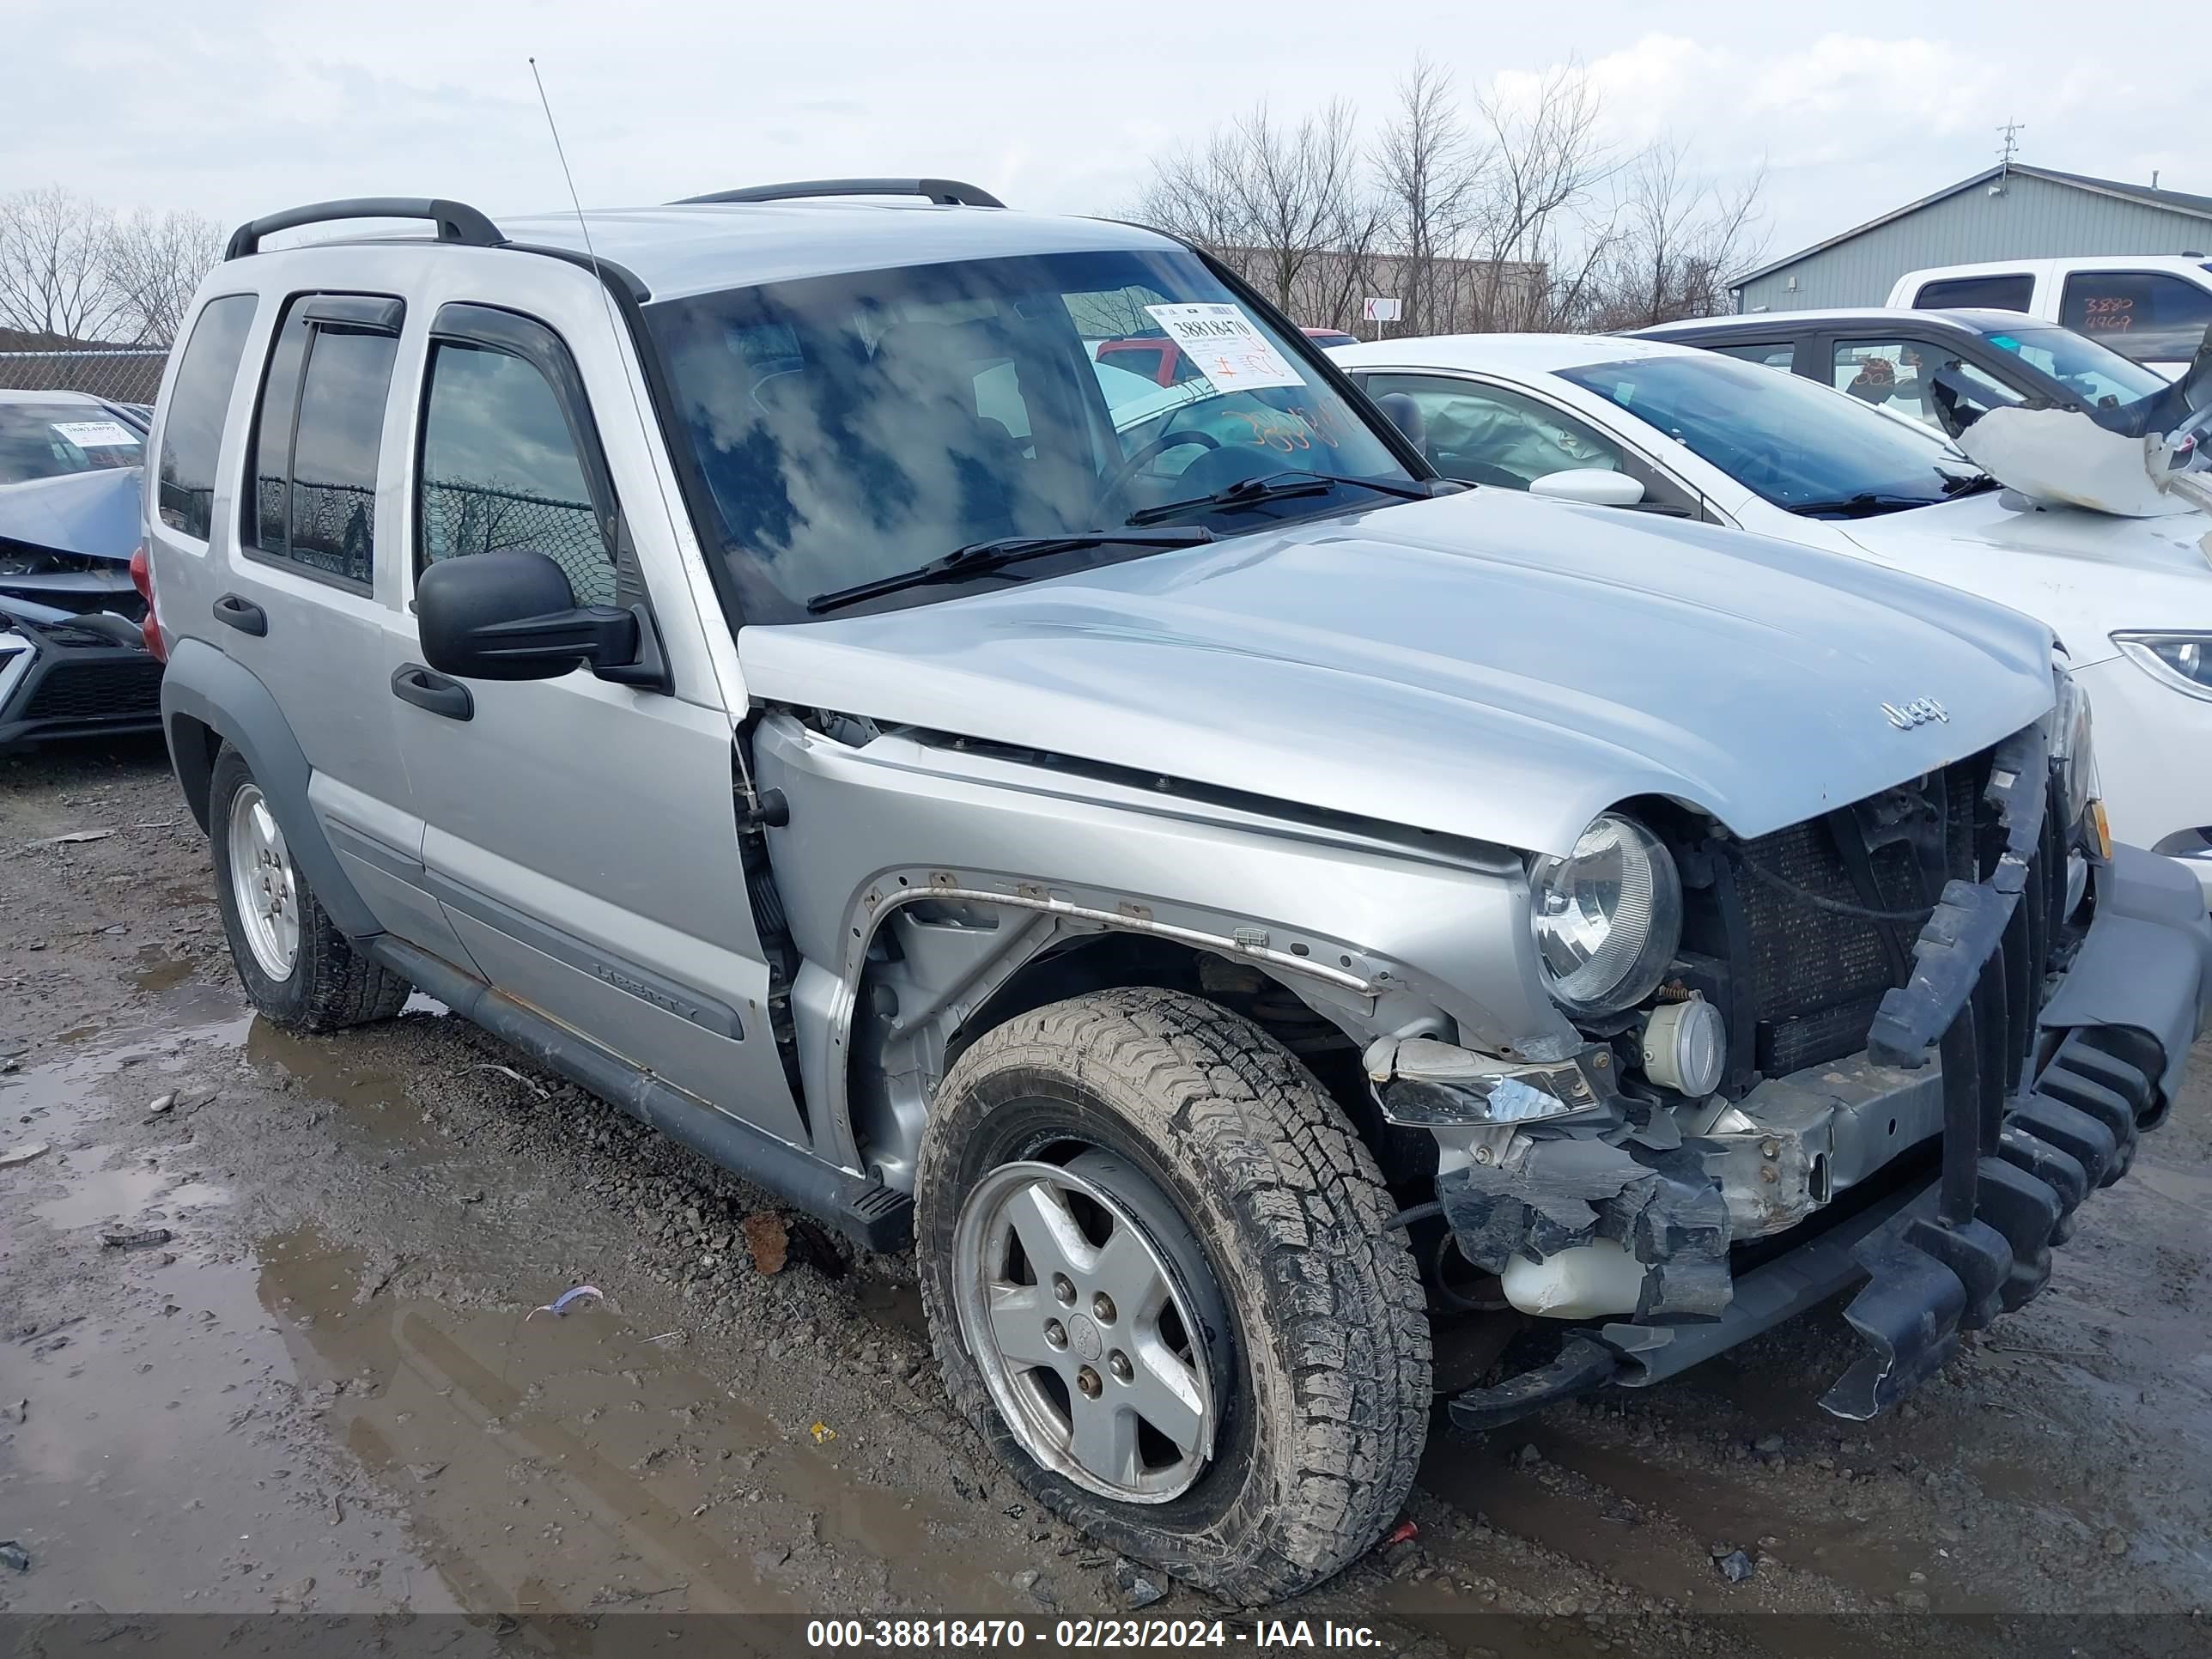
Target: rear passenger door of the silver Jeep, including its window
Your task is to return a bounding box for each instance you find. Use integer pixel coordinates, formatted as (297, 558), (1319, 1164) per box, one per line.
(208, 292), (469, 964)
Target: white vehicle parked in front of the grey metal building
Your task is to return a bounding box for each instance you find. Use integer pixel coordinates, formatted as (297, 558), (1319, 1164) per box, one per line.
(1887, 252), (2212, 380)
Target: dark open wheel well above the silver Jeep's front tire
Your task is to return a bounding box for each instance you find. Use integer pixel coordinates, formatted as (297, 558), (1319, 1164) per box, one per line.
(945, 933), (1436, 1188)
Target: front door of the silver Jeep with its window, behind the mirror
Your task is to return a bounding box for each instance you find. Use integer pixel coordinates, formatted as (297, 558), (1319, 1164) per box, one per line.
(387, 303), (807, 1144)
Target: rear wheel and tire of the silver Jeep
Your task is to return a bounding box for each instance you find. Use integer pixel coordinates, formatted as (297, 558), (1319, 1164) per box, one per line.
(208, 744), (411, 1030)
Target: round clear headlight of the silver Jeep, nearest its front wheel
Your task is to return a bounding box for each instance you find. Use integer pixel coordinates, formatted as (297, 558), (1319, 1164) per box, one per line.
(1528, 811), (1681, 1015)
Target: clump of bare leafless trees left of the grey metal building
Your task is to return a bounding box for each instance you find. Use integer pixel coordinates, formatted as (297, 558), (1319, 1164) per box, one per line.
(1128, 58), (1763, 334)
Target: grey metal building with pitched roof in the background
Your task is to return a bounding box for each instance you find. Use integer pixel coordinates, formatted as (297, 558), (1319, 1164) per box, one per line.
(1729, 161), (2212, 312)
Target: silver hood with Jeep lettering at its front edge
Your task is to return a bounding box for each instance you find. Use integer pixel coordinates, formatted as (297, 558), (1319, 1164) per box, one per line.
(738, 489), (2053, 852)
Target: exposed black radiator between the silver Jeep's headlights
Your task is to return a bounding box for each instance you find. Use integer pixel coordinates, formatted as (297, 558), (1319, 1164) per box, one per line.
(1735, 754), (2034, 1078)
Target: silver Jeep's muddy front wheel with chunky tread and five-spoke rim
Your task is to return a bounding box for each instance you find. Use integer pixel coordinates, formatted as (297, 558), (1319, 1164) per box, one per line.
(915, 988), (1429, 1606)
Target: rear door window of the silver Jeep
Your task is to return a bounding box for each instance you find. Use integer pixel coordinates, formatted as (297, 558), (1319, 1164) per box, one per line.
(243, 295), (398, 588)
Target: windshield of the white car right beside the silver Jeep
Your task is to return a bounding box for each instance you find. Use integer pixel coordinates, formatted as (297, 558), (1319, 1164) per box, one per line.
(1558, 352), (1986, 518)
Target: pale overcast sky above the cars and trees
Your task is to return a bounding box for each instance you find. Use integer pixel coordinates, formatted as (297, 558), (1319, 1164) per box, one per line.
(0, 0), (2212, 266)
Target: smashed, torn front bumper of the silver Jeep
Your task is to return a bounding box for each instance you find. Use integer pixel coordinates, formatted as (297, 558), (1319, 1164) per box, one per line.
(1415, 848), (2212, 1429)
